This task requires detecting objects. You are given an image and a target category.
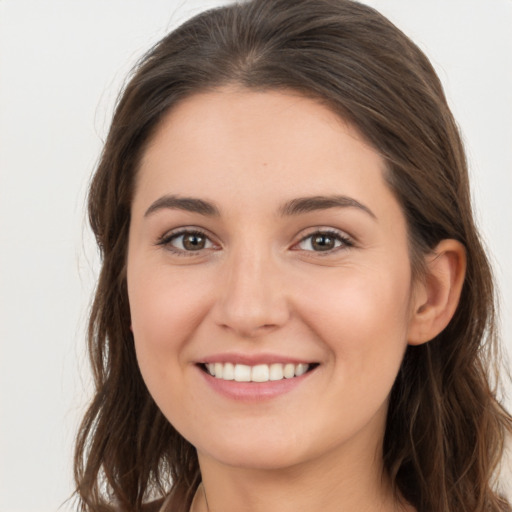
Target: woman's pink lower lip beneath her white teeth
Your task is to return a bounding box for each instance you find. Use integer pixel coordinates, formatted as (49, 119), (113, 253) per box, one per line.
(198, 368), (315, 402)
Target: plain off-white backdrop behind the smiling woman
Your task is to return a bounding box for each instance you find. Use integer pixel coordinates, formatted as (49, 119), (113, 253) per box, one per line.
(0, 0), (512, 512)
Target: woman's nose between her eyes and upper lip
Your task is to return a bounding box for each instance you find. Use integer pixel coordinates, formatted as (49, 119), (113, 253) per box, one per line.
(215, 248), (290, 338)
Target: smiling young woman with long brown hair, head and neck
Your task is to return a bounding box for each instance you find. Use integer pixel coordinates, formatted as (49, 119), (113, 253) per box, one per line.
(75, 0), (512, 512)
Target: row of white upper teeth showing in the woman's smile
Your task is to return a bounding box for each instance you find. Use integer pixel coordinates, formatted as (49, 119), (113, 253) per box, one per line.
(206, 363), (310, 382)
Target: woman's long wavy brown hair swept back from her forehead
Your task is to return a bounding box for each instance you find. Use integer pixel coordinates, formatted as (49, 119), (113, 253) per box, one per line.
(75, 0), (512, 512)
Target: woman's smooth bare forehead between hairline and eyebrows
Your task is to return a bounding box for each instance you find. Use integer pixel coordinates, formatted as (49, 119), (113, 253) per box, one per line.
(135, 88), (393, 220)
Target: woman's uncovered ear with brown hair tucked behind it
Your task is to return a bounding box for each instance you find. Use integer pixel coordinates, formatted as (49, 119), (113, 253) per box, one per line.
(408, 239), (466, 345)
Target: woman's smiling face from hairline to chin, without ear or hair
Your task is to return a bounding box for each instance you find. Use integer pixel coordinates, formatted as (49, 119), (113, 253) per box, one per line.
(128, 88), (420, 468)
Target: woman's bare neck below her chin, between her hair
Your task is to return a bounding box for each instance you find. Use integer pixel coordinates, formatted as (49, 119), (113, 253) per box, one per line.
(191, 440), (411, 512)
